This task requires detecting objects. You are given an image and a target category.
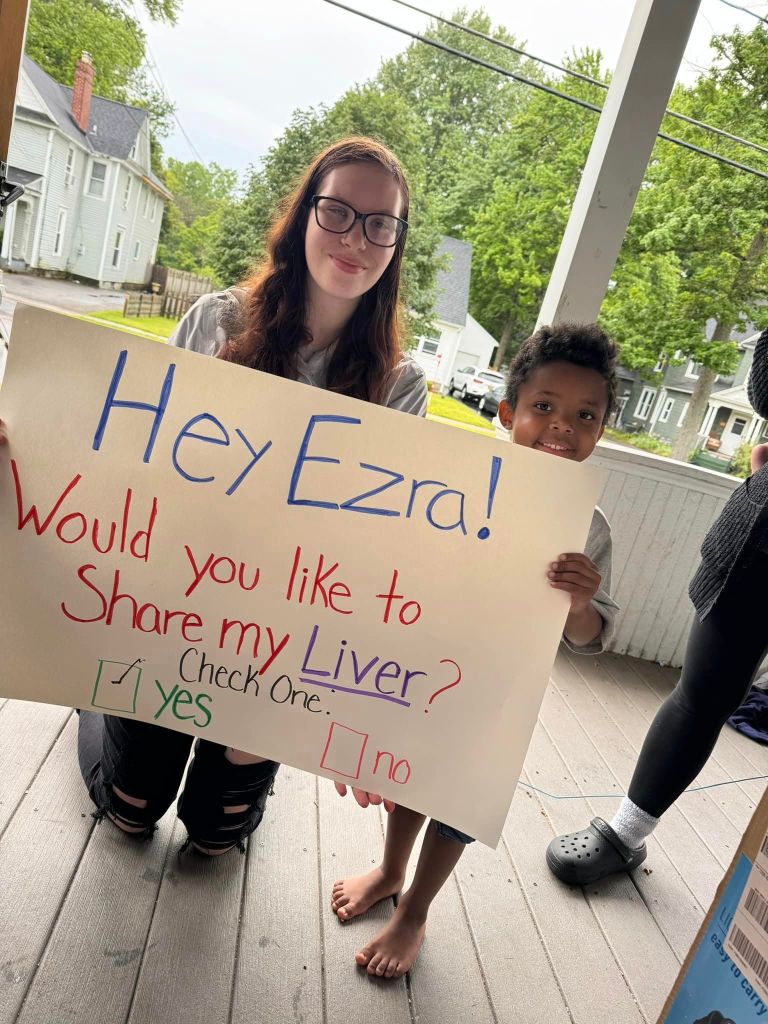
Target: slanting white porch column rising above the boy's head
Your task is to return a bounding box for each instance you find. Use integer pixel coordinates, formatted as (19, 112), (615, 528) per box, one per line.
(538, 0), (699, 324)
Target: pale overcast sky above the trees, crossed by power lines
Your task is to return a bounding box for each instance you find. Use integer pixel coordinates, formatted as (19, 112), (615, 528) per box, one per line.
(137, 0), (768, 172)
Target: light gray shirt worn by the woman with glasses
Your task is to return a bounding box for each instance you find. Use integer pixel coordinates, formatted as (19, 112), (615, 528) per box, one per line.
(170, 290), (427, 416)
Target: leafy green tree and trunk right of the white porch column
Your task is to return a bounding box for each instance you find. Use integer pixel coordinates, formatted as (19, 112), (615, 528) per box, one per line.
(602, 26), (768, 459)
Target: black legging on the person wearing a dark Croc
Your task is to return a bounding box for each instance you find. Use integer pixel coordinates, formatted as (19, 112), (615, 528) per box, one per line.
(629, 550), (768, 818)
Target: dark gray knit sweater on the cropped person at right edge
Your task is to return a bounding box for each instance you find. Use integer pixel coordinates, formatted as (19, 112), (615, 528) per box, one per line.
(688, 331), (768, 618)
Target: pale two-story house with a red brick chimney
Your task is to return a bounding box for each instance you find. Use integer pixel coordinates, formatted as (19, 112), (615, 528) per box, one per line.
(0, 53), (171, 288)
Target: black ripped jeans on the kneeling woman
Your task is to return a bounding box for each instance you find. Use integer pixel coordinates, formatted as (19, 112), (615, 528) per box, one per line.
(78, 711), (280, 851)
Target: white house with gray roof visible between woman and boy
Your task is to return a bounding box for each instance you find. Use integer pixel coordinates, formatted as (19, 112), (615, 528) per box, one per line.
(413, 237), (499, 384)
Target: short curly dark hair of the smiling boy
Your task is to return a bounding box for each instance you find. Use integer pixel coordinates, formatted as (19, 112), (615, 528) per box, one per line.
(506, 324), (618, 423)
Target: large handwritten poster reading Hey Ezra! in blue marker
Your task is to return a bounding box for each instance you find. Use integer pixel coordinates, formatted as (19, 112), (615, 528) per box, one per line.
(0, 306), (597, 845)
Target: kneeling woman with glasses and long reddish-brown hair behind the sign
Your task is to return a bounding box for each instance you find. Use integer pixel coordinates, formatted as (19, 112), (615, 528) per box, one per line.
(73, 138), (427, 855)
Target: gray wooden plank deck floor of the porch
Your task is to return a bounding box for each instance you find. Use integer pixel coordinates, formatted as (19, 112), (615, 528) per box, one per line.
(0, 653), (768, 1024)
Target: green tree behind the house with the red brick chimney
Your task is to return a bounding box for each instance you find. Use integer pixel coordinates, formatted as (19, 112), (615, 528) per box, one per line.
(25, 0), (180, 138)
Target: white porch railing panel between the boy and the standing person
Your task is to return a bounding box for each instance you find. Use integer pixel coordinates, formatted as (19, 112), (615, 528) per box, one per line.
(590, 441), (742, 667)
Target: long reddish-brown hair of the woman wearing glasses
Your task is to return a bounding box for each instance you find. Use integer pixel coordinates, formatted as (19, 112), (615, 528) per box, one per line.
(219, 137), (409, 402)
